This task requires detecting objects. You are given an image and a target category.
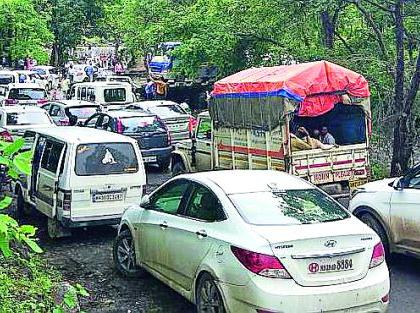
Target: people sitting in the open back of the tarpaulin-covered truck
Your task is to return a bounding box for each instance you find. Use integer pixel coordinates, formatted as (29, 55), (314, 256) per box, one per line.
(291, 126), (338, 151)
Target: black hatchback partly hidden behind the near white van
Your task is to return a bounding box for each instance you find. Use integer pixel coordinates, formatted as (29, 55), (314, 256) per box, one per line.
(84, 110), (172, 170)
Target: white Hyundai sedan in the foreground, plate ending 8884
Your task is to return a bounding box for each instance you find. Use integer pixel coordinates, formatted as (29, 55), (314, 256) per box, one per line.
(113, 171), (390, 313)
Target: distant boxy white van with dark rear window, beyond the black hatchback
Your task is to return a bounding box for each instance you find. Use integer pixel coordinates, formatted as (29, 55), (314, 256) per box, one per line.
(70, 82), (136, 106)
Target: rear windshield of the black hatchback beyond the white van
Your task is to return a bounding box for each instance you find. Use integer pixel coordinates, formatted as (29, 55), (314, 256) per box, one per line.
(117, 116), (166, 134)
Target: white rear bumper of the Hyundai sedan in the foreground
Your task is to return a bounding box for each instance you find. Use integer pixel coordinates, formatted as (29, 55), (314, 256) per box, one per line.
(219, 264), (390, 313)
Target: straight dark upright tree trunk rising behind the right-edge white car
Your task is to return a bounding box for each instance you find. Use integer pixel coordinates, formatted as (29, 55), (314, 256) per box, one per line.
(391, 0), (411, 176)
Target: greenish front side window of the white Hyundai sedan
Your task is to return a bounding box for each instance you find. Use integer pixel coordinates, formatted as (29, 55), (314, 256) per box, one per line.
(150, 180), (188, 214)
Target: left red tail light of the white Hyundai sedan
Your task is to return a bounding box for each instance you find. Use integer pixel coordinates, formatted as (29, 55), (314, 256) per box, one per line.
(231, 246), (292, 278)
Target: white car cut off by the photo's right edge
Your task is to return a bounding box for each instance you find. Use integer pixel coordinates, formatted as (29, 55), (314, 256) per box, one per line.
(349, 164), (420, 258)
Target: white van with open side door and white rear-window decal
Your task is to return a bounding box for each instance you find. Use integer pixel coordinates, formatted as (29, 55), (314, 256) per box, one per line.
(13, 126), (146, 238)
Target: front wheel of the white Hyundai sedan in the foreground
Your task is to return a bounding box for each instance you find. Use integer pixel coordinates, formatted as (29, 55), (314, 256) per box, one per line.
(112, 230), (145, 278)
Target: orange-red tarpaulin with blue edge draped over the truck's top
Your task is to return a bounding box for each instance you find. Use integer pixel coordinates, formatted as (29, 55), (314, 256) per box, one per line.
(212, 61), (370, 116)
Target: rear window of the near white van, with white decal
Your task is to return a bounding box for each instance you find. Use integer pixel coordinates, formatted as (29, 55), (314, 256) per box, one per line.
(75, 142), (139, 176)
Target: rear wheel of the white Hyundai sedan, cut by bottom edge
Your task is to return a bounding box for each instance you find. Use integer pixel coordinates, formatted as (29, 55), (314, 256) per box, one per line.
(195, 273), (226, 313)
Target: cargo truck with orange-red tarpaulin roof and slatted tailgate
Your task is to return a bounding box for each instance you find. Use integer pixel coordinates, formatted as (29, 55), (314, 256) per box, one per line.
(171, 61), (371, 198)
